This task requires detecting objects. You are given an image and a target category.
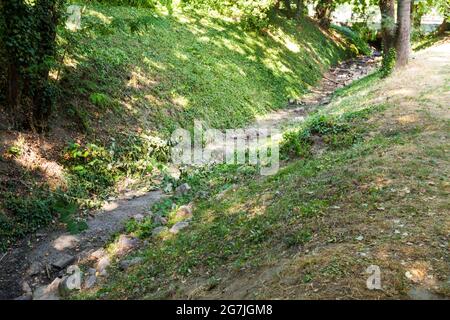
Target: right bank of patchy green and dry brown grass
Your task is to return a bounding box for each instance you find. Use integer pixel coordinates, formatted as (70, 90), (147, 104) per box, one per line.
(83, 42), (450, 299)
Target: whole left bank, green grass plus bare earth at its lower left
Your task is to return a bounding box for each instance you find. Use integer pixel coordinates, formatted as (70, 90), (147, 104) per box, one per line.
(0, 5), (352, 248)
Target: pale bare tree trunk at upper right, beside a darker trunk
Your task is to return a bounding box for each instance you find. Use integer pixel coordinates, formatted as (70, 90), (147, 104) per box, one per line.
(395, 0), (411, 67)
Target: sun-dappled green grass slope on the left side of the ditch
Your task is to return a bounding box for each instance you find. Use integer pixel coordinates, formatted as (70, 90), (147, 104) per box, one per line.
(62, 5), (346, 134)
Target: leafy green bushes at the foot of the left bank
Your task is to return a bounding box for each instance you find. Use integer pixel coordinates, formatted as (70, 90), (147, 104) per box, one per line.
(64, 135), (169, 207)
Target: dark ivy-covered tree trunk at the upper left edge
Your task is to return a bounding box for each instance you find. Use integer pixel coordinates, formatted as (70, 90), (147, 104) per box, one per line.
(0, 0), (64, 131)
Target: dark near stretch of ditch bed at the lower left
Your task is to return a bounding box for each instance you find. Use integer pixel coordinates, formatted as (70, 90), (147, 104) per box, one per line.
(0, 191), (164, 299)
